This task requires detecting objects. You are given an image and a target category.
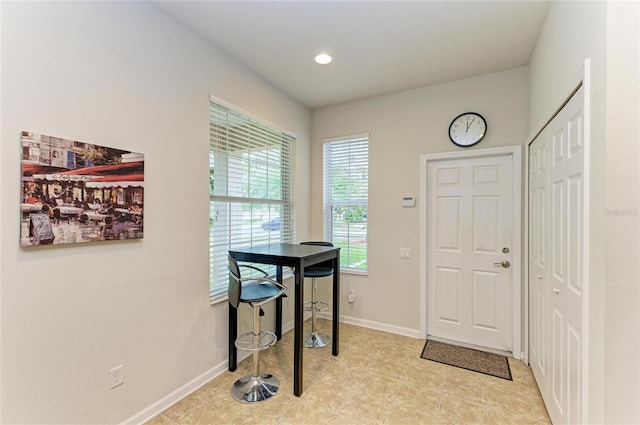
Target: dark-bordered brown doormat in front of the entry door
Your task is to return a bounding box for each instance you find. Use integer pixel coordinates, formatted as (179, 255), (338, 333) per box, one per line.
(420, 340), (513, 381)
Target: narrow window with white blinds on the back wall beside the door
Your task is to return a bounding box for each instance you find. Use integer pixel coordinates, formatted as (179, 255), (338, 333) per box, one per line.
(323, 134), (369, 272)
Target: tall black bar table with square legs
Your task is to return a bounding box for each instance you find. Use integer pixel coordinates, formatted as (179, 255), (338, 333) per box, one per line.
(229, 243), (340, 397)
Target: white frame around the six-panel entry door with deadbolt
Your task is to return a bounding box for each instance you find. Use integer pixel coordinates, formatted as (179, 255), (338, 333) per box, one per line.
(420, 145), (526, 360)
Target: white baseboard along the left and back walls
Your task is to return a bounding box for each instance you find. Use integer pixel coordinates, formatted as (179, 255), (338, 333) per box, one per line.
(120, 312), (420, 425)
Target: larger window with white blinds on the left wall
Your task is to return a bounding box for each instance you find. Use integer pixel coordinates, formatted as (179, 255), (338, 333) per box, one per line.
(209, 100), (295, 301)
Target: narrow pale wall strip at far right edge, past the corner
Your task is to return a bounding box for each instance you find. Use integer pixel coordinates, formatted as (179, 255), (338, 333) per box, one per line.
(604, 2), (640, 424)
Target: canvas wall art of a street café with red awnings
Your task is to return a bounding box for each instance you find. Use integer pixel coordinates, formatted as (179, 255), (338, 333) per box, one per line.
(20, 131), (144, 248)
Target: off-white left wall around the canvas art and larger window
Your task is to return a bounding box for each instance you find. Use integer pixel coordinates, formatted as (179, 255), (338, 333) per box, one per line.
(0, 2), (310, 424)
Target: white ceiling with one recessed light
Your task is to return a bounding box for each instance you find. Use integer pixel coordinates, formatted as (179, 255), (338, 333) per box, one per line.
(150, 0), (549, 109)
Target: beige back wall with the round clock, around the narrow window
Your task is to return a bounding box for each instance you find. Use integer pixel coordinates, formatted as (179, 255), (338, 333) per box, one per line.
(311, 68), (528, 336)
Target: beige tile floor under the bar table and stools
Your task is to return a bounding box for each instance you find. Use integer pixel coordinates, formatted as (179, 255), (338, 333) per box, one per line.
(147, 320), (551, 425)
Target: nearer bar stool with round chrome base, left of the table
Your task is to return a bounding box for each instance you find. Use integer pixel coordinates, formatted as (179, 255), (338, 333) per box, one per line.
(229, 256), (287, 403)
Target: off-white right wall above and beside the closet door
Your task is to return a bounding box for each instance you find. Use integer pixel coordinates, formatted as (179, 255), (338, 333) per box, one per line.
(529, 2), (640, 423)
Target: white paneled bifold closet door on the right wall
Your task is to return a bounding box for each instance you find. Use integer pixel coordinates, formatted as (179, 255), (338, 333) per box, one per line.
(529, 88), (585, 424)
